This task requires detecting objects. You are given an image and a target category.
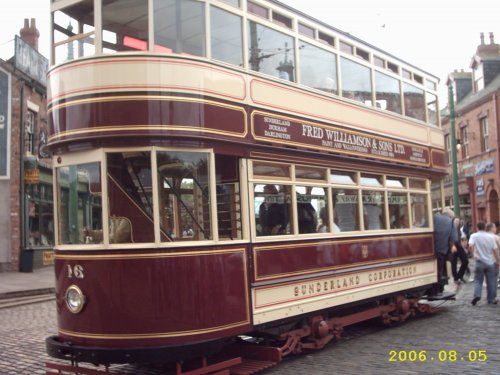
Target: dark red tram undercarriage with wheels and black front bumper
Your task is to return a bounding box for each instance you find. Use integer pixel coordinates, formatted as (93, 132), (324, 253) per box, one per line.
(46, 292), (455, 375)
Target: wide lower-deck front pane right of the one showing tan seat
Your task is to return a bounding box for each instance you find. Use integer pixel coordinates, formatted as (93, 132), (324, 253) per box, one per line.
(157, 151), (212, 241)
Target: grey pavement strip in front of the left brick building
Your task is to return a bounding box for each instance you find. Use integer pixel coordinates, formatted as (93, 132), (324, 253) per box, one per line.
(0, 266), (55, 299)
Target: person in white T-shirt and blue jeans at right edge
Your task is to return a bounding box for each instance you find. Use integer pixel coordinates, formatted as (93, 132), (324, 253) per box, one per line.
(469, 221), (499, 306)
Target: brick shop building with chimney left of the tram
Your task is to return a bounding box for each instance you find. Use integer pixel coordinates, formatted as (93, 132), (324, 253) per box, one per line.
(0, 19), (53, 271)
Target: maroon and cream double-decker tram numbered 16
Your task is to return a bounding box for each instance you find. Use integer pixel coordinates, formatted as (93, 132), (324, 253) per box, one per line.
(47, 0), (445, 372)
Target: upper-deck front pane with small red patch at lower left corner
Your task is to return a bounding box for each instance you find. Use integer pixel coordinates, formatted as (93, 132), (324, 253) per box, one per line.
(154, 0), (206, 56)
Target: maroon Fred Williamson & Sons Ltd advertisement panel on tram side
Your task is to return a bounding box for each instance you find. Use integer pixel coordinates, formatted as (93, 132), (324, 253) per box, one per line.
(252, 111), (430, 166)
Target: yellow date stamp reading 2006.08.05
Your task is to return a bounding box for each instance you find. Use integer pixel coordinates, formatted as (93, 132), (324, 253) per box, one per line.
(389, 349), (488, 362)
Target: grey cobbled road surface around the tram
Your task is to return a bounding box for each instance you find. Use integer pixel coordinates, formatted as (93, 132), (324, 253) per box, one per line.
(0, 284), (500, 375)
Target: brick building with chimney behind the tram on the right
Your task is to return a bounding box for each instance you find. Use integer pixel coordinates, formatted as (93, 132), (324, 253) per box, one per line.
(442, 33), (500, 226)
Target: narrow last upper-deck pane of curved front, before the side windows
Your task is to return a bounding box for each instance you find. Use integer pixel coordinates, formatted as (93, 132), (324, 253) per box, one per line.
(210, 6), (243, 66)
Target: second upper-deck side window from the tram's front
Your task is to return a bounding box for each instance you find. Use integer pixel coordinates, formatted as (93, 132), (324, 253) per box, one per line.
(299, 41), (338, 94)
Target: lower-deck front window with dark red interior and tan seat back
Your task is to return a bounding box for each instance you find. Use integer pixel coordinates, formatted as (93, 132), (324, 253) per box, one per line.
(107, 151), (154, 243)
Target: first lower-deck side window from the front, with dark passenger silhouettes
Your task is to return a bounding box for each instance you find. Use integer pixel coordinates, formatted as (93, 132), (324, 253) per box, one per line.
(254, 184), (293, 236)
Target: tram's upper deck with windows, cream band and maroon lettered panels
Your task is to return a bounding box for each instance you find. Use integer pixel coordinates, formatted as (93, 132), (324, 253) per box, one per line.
(49, 0), (444, 159)
